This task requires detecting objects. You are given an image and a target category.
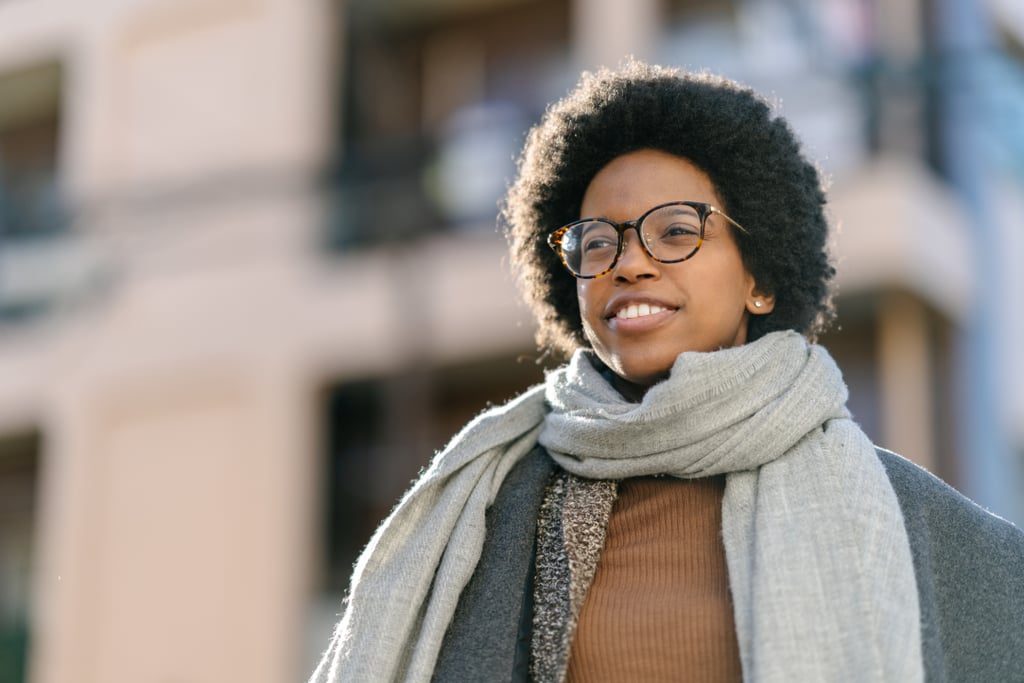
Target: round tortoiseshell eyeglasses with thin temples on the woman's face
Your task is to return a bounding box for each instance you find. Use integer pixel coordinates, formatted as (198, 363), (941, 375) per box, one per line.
(548, 202), (750, 279)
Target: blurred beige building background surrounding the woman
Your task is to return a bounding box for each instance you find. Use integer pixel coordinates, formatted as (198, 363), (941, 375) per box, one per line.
(0, 0), (1024, 683)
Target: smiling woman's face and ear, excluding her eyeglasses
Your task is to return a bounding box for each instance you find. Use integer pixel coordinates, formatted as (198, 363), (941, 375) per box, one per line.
(577, 150), (774, 391)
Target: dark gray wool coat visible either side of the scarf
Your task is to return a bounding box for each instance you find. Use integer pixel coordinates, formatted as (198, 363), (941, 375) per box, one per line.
(434, 446), (1024, 683)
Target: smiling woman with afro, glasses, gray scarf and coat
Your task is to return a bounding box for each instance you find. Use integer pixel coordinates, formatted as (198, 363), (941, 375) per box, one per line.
(311, 62), (1024, 681)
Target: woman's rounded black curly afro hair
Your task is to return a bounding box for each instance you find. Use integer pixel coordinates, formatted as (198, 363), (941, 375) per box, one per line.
(502, 60), (835, 354)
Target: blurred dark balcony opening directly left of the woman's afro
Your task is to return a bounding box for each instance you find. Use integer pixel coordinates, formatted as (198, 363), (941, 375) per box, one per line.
(329, 0), (569, 247)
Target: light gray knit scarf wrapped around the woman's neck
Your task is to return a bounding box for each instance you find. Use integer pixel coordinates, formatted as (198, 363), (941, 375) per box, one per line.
(309, 332), (924, 683)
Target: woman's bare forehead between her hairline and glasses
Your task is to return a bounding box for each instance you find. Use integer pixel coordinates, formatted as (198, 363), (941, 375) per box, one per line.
(580, 150), (722, 220)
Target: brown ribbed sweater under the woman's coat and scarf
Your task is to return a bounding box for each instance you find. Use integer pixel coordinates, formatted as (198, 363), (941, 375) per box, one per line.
(567, 477), (742, 682)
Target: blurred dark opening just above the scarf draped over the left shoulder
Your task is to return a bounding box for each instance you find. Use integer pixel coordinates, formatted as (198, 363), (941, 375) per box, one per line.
(322, 356), (543, 592)
